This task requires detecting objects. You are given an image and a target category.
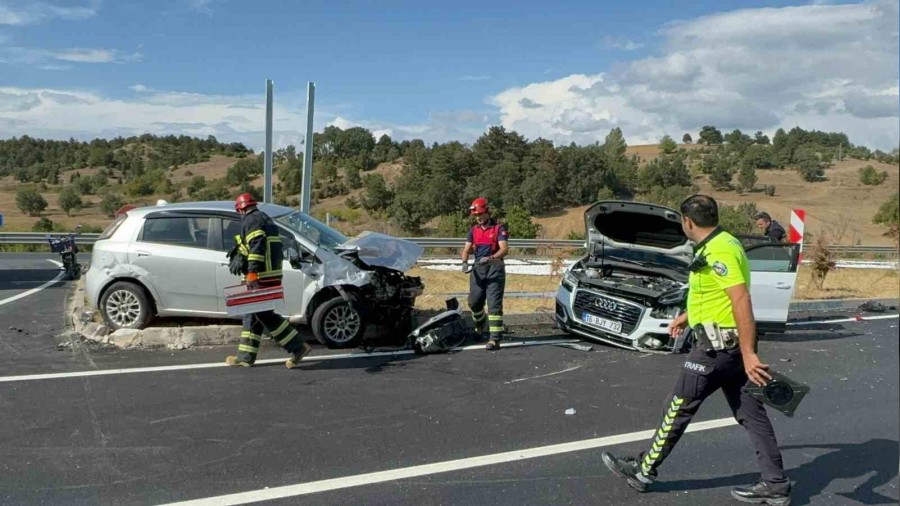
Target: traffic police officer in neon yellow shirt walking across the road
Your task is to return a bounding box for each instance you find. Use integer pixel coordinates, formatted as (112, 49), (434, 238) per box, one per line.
(602, 195), (791, 506)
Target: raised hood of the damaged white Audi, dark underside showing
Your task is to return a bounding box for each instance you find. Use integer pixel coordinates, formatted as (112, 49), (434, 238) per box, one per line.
(584, 200), (694, 268)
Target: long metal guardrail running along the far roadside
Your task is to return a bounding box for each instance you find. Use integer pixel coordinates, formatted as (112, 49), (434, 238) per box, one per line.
(0, 232), (897, 257)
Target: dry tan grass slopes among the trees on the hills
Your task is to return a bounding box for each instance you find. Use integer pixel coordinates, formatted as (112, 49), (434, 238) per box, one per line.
(0, 140), (900, 245)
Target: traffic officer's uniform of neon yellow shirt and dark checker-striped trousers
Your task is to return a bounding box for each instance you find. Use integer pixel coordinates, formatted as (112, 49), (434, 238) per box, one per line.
(638, 229), (790, 493)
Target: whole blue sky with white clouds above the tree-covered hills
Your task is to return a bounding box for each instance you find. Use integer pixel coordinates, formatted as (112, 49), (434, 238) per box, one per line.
(0, 0), (900, 149)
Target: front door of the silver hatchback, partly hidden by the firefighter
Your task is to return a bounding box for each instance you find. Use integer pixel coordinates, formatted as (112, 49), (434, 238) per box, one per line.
(216, 217), (308, 316)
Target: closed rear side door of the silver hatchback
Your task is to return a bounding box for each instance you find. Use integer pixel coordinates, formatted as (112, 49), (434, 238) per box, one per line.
(128, 213), (219, 315)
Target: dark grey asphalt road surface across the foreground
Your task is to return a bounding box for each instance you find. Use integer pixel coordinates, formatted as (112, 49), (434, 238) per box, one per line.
(0, 256), (900, 505)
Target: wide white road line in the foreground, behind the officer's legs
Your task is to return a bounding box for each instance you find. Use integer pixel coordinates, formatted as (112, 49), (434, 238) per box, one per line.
(168, 418), (737, 506)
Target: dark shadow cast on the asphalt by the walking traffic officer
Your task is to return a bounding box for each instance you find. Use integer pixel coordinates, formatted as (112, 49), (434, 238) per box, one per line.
(657, 439), (900, 505)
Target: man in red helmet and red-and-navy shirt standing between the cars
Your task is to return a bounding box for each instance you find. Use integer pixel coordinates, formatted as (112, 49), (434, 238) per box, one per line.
(462, 198), (509, 351)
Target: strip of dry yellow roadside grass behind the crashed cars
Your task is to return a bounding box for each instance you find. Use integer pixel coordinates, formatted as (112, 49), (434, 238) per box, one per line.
(410, 266), (900, 313)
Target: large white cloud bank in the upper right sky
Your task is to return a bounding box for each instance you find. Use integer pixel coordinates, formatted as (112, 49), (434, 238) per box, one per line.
(490, 0), (900, 149)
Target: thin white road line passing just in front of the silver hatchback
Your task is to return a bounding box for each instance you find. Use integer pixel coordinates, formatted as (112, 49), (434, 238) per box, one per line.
(0, 339), (577, 383)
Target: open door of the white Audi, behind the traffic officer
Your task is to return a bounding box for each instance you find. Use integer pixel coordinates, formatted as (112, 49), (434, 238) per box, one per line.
(746, 243), (800, 332)
